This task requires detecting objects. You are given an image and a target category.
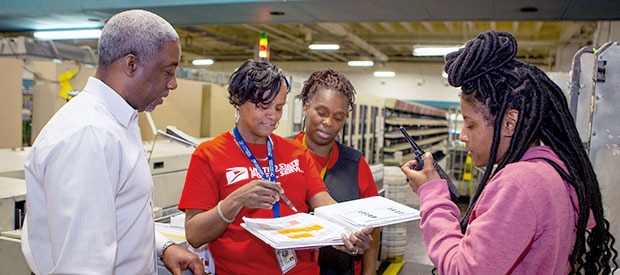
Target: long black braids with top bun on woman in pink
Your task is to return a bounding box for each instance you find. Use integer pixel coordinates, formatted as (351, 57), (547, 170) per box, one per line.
(445, 31), (618, 274)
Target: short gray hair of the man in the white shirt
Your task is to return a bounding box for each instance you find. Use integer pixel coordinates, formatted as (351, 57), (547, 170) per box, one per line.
(99, 10), (179, 66)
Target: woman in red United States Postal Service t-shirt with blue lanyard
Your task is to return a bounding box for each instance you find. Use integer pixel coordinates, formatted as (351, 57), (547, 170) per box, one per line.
(179, 60), (372, 275)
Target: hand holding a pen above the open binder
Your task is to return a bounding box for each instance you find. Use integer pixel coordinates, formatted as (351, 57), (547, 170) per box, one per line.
(229, 180), (284, 209)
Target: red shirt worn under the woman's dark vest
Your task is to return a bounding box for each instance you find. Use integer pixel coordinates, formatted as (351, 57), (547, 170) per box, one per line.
(295, 132), (379, 274)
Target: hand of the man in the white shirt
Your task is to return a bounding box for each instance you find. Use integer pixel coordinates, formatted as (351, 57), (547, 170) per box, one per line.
(164, 244), (205, 275)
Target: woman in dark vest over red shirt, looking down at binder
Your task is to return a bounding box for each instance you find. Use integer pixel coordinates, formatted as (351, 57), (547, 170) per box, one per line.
(295, 69), (381, 275)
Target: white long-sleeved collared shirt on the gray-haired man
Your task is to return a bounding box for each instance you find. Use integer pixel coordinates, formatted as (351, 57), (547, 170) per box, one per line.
(22, 77), (166, 274)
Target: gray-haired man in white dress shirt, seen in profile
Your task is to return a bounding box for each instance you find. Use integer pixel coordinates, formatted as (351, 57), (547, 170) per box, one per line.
(22, 10), (203, 275)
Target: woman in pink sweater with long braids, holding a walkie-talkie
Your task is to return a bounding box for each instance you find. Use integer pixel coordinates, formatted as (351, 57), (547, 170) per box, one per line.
(402, 31), (618, 274)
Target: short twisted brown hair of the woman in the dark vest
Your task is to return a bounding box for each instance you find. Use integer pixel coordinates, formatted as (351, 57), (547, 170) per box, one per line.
(300, 68), (355, 111)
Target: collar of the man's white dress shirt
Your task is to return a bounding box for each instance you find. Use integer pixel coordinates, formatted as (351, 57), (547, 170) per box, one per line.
(84, 77), (138, 128)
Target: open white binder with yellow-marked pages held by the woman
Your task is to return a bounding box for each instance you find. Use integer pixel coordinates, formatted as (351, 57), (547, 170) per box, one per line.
(241, 196), (420, 249)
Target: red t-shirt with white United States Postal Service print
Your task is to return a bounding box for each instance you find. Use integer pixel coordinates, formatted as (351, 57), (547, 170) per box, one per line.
(179, 132), (327, 275)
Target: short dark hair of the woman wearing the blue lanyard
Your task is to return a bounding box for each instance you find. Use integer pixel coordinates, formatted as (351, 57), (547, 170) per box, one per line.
(228, 59), (291, 106)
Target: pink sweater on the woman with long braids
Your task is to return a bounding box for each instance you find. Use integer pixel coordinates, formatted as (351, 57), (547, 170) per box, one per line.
(418, 146), (595, 274)
